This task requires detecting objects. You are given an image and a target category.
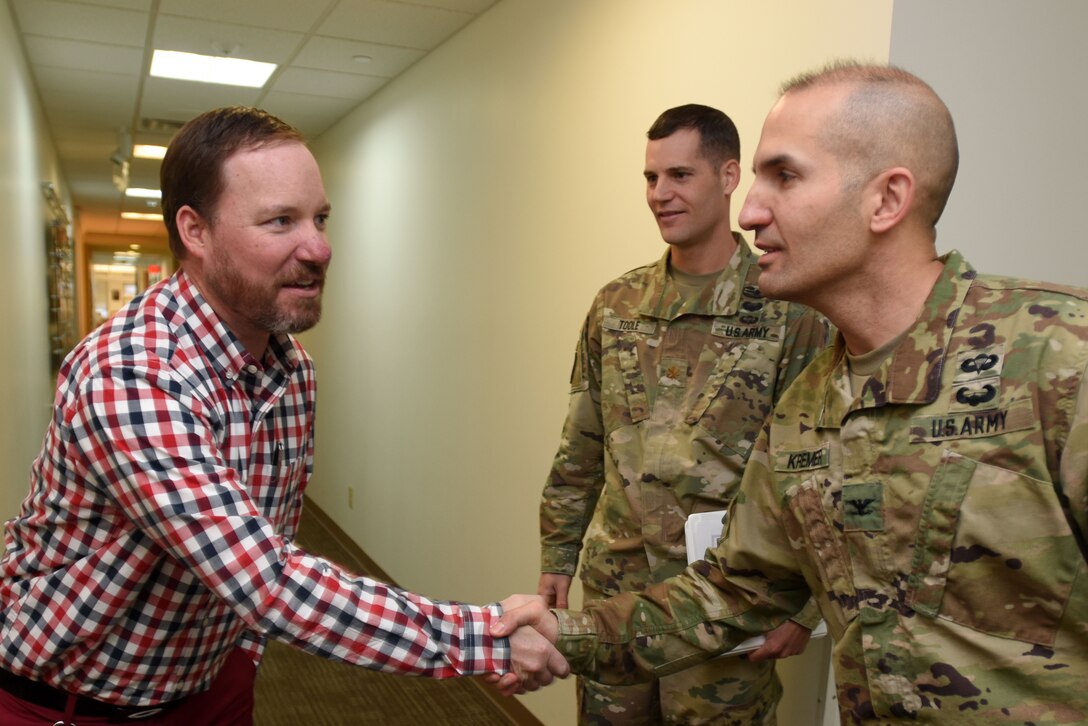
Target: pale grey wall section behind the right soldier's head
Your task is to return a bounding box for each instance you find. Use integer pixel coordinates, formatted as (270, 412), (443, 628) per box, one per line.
(890, 0), (1088, 286)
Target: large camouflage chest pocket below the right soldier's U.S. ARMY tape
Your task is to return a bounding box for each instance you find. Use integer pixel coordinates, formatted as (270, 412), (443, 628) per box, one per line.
(910, 451), (1080, 644)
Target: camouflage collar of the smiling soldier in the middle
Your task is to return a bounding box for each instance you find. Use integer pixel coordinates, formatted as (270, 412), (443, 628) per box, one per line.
(638, 232), (758, 320)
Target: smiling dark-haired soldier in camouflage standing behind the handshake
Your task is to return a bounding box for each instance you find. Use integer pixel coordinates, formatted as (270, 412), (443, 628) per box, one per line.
(540, 104), (827, 726)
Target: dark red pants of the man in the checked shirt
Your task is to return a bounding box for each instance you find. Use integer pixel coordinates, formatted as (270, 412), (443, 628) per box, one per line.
(0, 650), (257, 726)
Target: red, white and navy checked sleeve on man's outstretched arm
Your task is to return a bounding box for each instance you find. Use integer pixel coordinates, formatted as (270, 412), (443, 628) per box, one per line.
(70, 364), (509, 678)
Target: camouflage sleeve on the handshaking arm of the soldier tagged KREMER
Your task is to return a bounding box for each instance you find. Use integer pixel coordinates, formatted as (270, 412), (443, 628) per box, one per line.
(554, 429), (811, 684)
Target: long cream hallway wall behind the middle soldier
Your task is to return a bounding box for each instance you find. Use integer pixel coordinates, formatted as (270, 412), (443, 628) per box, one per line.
(305, 0), (892, 726)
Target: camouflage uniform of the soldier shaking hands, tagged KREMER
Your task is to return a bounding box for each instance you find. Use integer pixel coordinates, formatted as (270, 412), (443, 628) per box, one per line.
(558, 253), (1088, 726)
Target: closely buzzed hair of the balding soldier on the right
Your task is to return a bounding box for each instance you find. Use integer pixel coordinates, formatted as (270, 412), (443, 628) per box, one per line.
(781, 61), (960, 226)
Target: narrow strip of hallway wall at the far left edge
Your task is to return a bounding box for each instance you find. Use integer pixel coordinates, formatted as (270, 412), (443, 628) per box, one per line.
(0, 3), (64, 539)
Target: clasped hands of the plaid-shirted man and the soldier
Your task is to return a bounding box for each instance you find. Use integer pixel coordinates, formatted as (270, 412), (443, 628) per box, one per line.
(484, 596), (570, 696)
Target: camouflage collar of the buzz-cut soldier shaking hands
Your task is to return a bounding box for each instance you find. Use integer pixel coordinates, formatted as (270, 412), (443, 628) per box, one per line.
(820, 250), (978, 428)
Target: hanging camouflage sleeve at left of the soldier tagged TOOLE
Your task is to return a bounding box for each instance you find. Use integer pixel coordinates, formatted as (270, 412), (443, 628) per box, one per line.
(541, 305), (605, 577)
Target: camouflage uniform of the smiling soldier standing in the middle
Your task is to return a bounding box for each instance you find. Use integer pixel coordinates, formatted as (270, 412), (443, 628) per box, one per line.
(541, 235), (828, 725)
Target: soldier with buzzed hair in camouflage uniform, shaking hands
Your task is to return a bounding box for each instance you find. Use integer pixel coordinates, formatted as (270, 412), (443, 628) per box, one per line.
(505, 64), (1088, 726)
